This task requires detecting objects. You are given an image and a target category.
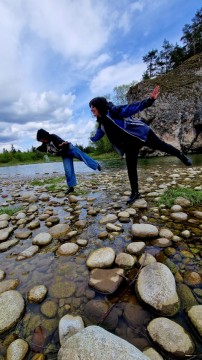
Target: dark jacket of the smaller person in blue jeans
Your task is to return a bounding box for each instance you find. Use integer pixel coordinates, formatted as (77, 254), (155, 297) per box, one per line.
(36, 133), (70, 158)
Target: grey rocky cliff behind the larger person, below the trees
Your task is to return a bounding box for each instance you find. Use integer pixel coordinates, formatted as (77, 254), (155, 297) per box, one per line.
(127, 54), (202, 154)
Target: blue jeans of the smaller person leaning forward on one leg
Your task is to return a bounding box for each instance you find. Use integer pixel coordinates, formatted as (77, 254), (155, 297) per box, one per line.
(62, 144), (99, 187)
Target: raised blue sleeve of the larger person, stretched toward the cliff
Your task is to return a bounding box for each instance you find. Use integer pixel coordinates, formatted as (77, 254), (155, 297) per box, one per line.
(109, 98), (155, 119)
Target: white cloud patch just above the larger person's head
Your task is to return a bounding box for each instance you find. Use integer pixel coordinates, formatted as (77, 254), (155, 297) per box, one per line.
(90, 61), (146, 95)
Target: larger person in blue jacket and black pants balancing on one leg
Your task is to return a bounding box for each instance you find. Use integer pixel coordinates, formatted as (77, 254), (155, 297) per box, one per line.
(89, 86), (192, 204)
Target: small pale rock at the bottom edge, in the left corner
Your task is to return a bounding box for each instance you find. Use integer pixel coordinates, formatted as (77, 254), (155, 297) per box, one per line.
(6, 339), (29, 360)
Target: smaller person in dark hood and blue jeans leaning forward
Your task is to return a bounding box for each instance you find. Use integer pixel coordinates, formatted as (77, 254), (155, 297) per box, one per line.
(36, 129), (101, 195)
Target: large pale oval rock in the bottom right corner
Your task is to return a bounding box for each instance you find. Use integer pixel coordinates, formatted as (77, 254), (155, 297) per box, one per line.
(147, 317), (195, 359)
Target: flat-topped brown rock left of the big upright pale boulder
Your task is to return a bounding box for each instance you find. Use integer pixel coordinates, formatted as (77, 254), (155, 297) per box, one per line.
(89, 268), (124, 294)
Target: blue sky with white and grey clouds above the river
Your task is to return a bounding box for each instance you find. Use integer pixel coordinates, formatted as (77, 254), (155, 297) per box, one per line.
(0, 0), (201, 152)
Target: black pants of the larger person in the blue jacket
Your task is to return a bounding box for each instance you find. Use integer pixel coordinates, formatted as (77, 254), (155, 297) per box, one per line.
(125, 129), (181, 193)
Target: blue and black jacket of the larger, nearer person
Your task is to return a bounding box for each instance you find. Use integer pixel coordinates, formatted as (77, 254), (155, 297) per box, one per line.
(91, 98), (155, 155)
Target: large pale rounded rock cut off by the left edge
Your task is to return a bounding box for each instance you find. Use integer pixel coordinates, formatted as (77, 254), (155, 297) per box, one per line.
(0, 290), (25, 334)
